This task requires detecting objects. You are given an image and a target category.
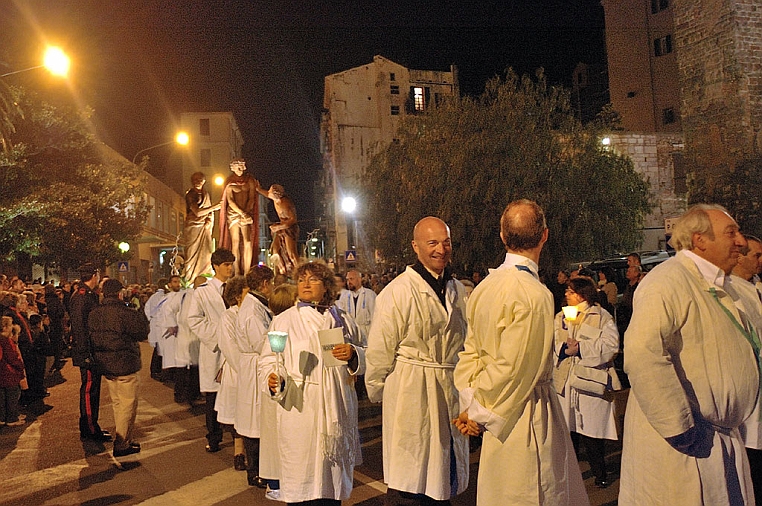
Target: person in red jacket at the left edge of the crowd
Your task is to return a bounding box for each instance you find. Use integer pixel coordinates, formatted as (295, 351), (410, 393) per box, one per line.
(0, 316), (26, 427)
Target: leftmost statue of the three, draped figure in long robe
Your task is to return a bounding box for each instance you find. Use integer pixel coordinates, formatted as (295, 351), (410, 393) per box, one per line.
(183, 172), (220, 280)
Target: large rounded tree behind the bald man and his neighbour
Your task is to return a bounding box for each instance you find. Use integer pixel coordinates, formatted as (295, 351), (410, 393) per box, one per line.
(364, 70), (651, 271)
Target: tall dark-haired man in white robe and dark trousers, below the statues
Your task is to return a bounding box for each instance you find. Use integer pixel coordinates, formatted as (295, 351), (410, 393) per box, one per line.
(188, 248), (235, 453)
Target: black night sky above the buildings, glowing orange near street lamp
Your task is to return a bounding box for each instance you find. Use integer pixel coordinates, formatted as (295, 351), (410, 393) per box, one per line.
(0, 0), (605, 228)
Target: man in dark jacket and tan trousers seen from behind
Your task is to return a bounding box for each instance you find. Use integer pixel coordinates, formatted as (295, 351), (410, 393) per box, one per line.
(88, 279), (148, 457)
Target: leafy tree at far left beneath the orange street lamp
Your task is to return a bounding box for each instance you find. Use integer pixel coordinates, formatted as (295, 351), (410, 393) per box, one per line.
(0, 86), (146, 268)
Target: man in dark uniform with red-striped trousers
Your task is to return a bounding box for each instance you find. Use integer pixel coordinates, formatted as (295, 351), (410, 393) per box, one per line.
(70, 267), (111, 441)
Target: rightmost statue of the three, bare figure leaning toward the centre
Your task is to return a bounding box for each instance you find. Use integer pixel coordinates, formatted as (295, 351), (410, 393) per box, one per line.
(257, 184), (299, 276)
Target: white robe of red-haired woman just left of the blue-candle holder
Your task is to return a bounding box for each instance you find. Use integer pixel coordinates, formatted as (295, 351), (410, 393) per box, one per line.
(235, 293), (277, 438)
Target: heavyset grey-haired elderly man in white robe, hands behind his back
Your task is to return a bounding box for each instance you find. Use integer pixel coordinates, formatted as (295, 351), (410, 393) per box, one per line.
(619, 204), (759, 506)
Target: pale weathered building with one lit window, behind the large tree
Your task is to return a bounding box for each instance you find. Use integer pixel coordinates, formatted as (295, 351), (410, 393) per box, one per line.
(316, 56), (459, 270)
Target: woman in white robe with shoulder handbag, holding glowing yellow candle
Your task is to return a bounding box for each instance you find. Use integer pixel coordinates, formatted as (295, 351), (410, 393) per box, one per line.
(553, 278), (621, 488)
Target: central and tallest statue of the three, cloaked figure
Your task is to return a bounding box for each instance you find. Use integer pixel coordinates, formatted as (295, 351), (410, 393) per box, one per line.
(220, 158), (259, 275)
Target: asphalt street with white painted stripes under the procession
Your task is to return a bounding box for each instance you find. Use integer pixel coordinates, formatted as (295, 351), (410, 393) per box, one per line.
(0, 343), (621, 506)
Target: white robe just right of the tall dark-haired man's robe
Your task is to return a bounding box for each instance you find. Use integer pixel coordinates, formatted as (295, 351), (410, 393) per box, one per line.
(214, 306), (241, 425)
